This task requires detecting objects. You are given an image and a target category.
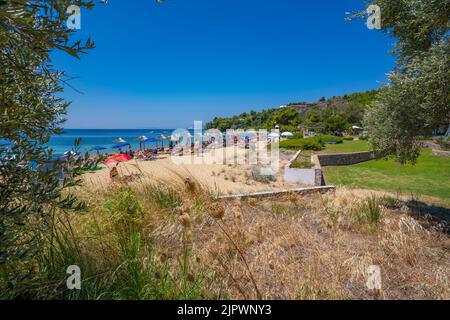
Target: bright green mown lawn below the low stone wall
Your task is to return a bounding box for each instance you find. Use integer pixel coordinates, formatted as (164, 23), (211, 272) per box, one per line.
(325, 149), (450, 205)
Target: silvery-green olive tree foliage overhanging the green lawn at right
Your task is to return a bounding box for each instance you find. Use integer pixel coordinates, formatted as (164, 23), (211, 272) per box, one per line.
(366, 0), (450, 162)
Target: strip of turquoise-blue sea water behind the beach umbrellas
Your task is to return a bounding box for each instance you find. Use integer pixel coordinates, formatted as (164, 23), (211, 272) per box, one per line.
(47, 129), (184, 155)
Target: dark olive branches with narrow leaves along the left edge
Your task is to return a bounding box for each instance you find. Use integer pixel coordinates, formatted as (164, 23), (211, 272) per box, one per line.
(0, 0), (93, 285)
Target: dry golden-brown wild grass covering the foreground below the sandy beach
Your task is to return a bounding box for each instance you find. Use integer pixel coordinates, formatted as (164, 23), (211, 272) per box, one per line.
(37, 175), (450, 299)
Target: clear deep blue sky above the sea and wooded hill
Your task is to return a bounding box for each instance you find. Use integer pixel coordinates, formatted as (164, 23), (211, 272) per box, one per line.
(53, 0), (394, 129)
